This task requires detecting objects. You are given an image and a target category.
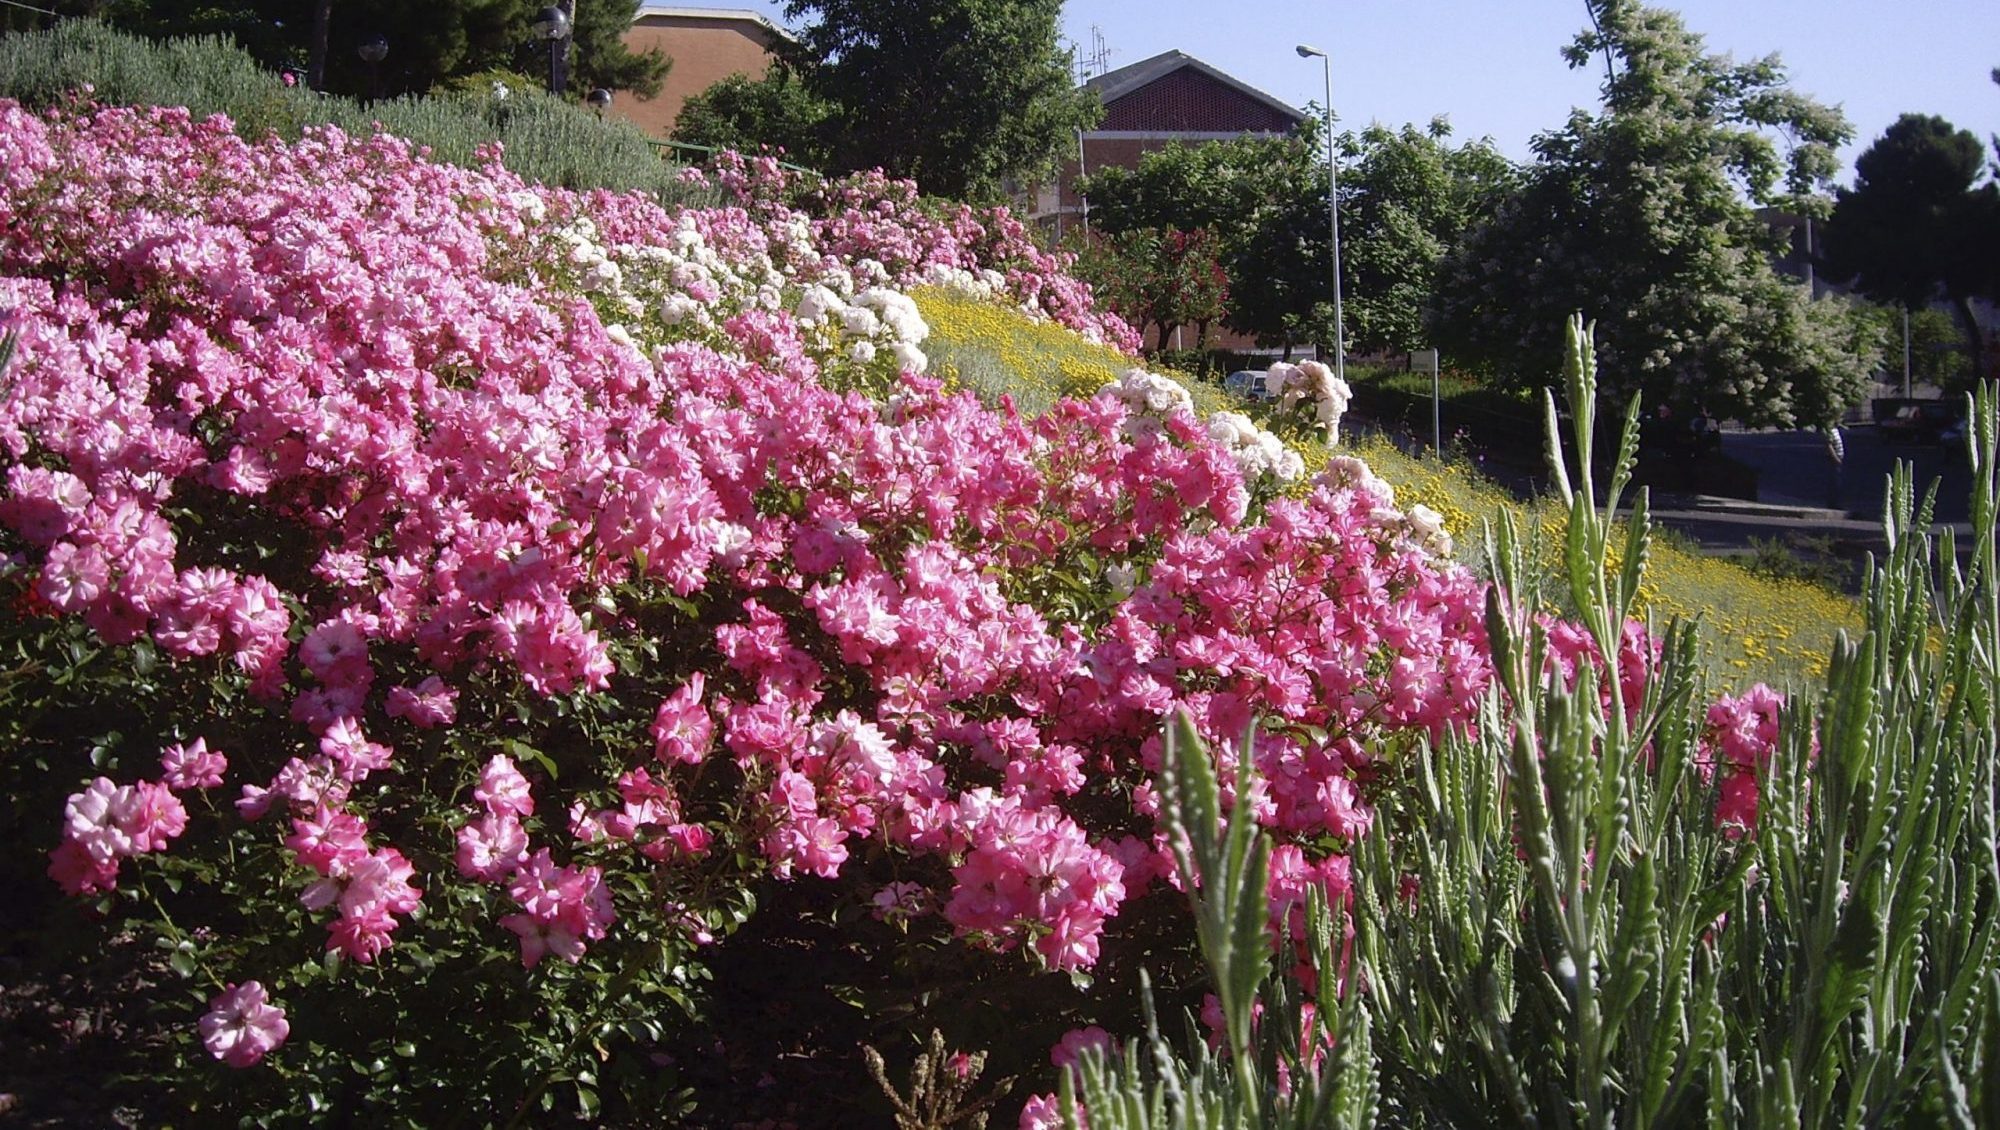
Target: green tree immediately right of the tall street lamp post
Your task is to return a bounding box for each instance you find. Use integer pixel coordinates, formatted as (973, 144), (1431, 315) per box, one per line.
(1340, 118), (1520, 352)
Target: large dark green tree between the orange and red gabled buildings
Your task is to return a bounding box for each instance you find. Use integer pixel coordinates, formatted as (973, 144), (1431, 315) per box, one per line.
(780, 0), (1102, 198)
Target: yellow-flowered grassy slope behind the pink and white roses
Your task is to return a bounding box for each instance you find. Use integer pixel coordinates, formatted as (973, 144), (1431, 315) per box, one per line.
(916, 290), (1860, 688)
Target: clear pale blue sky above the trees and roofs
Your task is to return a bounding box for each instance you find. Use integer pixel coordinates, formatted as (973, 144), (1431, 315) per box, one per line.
(718, 0), (2000, 180)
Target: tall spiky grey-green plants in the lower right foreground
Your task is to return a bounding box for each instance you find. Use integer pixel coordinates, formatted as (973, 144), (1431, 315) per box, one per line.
(1060, 322), (2000, 1130)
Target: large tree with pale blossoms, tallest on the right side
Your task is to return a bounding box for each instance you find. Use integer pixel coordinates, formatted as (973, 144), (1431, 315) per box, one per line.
(1430, 0), (1874, 426)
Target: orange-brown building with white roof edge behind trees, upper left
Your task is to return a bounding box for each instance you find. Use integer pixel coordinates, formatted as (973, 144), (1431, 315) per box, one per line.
(612, 0), (790, 140)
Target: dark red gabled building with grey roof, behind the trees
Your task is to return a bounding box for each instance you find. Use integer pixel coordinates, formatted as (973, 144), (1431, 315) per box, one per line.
(1028, 50), (1306, 236)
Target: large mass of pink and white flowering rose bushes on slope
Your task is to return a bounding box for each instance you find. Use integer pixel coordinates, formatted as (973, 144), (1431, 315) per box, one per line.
(0, 108), (1488, 1120)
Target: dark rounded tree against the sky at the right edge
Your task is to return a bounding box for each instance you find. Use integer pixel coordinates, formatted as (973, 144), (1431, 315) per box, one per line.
(1824, 114), (2000, 382)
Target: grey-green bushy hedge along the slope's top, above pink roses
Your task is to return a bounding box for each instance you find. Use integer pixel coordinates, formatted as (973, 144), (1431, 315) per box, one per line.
(0, 20), (712, 202)
